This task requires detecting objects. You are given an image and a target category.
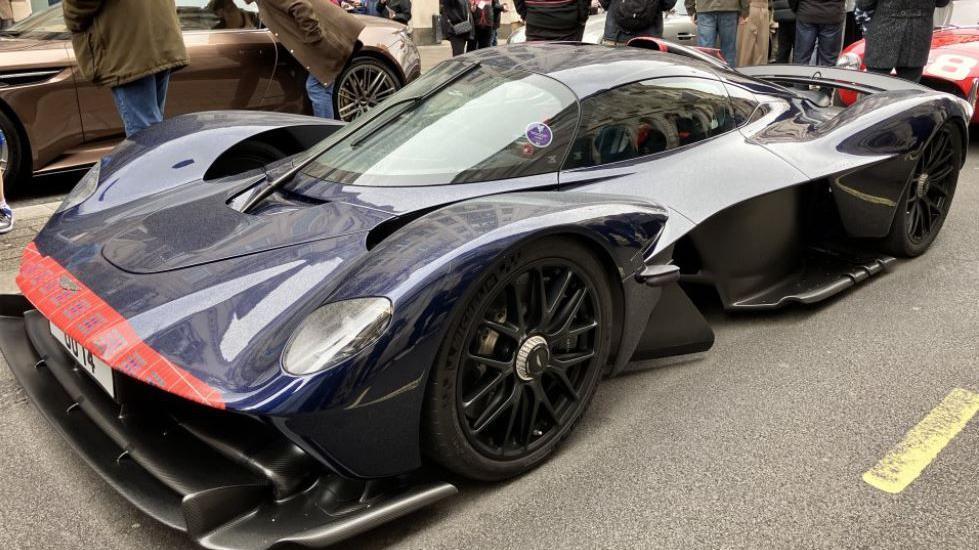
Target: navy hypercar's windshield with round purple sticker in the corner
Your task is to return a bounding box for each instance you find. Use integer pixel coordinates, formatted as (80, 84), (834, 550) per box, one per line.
(304, 61), (578, 187)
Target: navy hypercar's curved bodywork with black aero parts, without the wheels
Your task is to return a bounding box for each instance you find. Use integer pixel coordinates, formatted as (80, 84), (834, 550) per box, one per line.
(0, 44), (972, 547)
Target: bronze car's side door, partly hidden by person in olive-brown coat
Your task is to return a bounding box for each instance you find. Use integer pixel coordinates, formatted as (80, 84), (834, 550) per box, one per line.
(78, 0), (281, 142)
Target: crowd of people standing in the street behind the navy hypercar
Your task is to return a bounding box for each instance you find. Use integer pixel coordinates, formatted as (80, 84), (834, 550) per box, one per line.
(0, 0), (949, 233)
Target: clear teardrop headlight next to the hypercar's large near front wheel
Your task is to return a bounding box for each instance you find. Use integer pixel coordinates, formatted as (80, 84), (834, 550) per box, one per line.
(282, 298), (393, 376)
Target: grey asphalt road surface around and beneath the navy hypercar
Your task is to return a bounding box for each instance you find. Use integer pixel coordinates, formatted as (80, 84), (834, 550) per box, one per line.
(0, 141), (979, 549)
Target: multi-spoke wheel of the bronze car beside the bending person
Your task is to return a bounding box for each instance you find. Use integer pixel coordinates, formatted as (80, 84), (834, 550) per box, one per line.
(333, 57), (401, 122)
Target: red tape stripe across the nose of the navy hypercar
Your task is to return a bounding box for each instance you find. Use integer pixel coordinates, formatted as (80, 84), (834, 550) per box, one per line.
(17, 243), (224, 409)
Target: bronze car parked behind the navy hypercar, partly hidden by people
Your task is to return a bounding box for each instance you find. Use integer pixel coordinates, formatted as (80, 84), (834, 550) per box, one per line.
(0, 0), (421, 192)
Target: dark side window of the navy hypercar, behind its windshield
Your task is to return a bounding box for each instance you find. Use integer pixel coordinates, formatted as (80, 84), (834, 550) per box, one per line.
(565, 78), (738, 169)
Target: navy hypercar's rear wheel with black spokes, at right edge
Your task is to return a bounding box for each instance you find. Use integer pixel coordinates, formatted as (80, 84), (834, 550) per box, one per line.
(884, 122), (962, 257)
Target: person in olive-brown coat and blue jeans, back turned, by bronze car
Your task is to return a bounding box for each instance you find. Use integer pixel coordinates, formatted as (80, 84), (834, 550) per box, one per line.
(62, 0), (187, 136)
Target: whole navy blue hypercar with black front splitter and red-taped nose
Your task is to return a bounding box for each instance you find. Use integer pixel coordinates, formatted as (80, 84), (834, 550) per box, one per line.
(0, 44), (972, 548)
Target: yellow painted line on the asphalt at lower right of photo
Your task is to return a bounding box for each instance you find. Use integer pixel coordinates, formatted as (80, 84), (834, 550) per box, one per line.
(863, 388), (979, 494)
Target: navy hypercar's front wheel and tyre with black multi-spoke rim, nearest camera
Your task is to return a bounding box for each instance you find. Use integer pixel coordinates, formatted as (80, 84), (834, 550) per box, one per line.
(423, 238), (613, 481)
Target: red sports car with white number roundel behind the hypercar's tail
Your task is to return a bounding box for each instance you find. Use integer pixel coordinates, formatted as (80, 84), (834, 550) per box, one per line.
(837, 0), (979, 123)
